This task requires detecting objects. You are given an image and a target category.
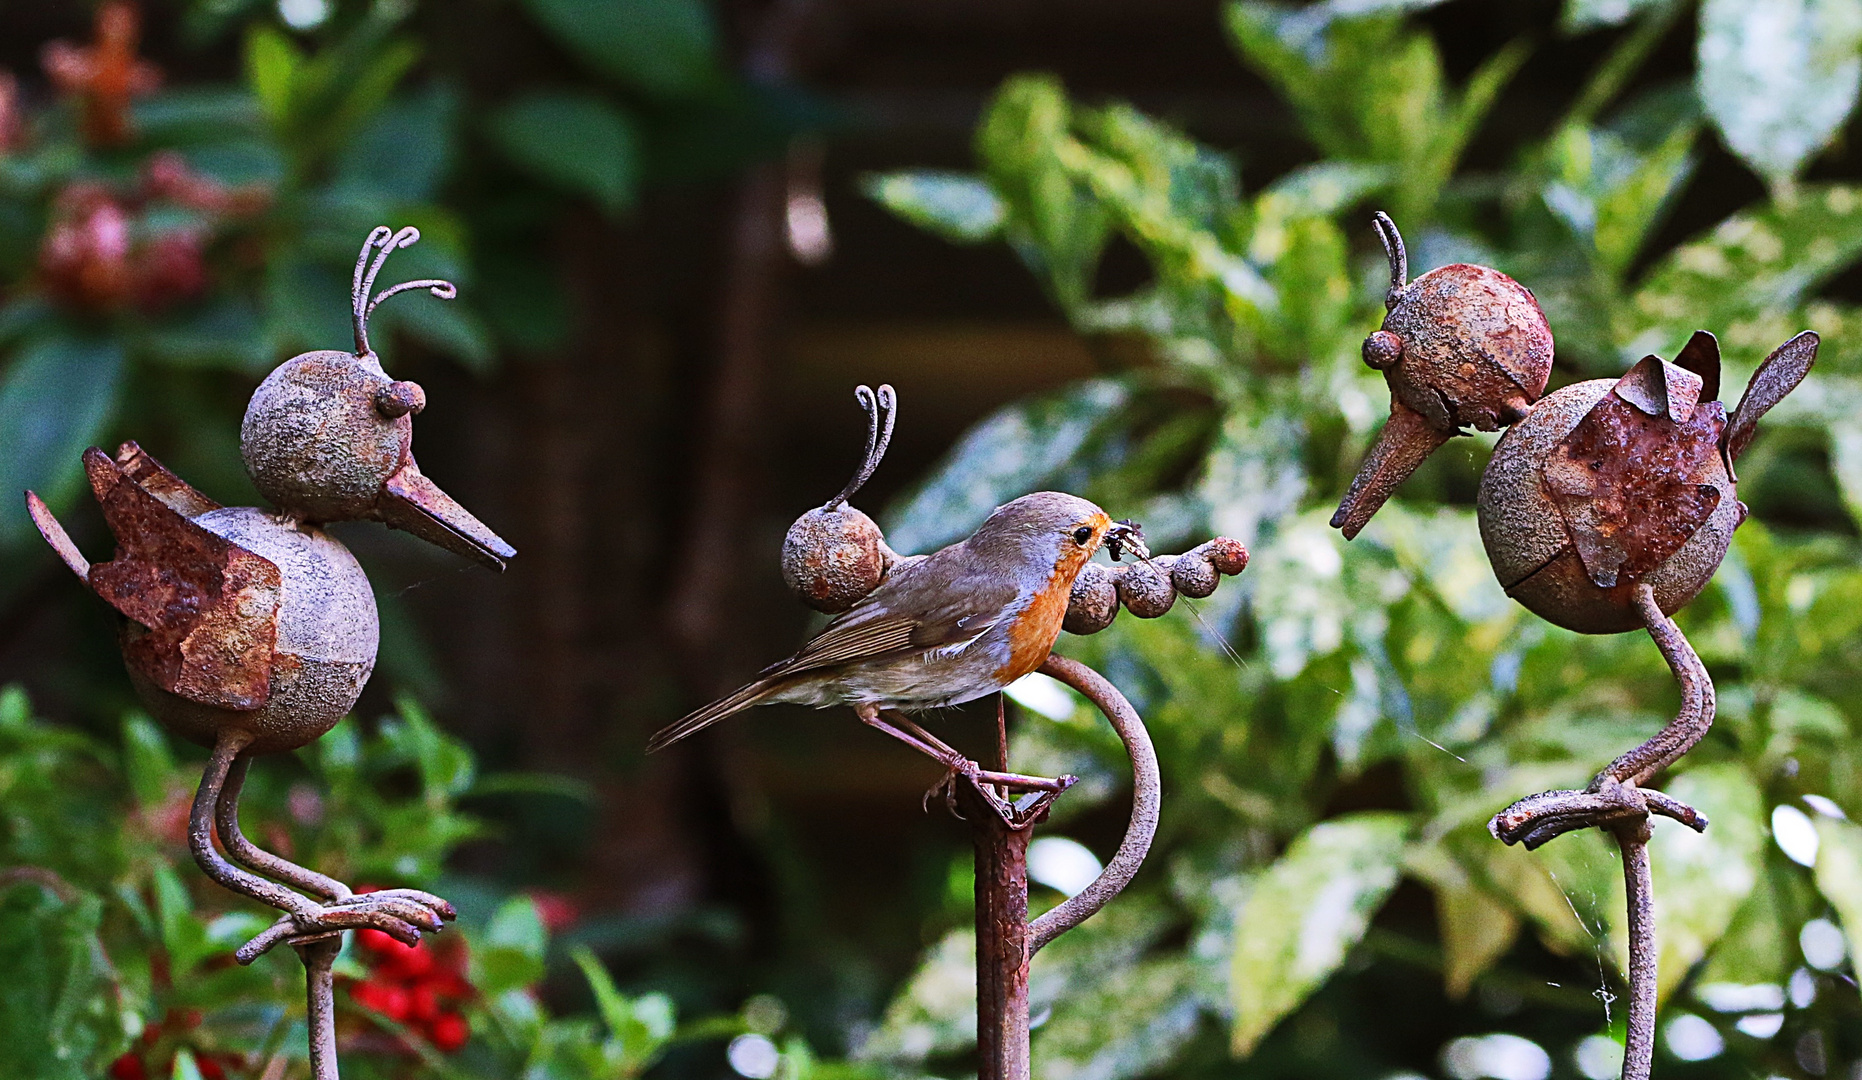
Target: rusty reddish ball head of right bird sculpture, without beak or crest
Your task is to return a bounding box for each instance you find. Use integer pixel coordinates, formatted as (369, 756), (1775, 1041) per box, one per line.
(1365, 263), (1553, 432)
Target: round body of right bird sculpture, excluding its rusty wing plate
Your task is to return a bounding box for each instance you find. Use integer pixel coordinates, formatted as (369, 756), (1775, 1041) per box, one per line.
(1478, 378), (1743, 633)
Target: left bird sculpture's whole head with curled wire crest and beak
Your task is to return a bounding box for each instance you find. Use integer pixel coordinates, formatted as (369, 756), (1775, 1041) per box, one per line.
(240, 229), (516, 570)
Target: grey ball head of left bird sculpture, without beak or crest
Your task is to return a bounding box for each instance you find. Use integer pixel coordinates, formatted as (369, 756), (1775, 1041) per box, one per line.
(240, 350), (413, 521)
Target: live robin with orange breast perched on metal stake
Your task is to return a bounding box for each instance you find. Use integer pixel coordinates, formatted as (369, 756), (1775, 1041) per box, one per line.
(646, 492), (1143, 778)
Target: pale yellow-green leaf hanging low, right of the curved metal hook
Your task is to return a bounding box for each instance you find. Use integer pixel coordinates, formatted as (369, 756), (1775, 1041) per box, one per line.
(1229, 814), (1410, 1058)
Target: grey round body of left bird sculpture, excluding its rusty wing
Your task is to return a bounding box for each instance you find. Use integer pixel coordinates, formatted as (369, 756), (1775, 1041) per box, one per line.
(123, 506), (380, 754)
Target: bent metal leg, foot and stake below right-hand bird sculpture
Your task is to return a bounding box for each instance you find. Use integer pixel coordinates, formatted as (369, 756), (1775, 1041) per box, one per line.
(1488, 583), (1715, 1080)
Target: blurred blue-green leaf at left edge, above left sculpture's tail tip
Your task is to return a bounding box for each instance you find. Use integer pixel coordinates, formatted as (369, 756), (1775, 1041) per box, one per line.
(0, 337), (123, 546)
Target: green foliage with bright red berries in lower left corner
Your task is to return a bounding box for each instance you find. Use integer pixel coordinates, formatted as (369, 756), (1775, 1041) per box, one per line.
(0, 687), (843, 1080)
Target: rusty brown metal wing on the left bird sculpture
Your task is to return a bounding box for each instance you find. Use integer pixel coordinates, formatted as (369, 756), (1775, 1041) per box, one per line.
(84, 447), (281, 711)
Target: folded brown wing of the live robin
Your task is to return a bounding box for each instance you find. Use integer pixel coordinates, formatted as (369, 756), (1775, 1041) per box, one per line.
(763, 560), (1020, 678)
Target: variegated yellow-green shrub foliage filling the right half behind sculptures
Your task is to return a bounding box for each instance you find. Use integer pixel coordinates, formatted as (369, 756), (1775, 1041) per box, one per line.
(858, 0), (1862, 1080)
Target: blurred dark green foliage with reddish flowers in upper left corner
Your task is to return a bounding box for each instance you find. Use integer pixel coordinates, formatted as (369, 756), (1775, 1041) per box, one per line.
(0, 0), (829, 566)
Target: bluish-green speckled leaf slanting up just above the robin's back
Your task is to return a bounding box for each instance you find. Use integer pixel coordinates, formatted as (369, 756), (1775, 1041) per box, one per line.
(886, 380), (1130, 553)
